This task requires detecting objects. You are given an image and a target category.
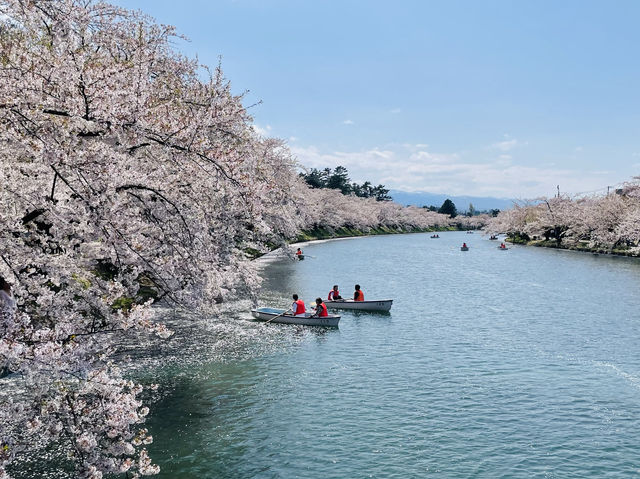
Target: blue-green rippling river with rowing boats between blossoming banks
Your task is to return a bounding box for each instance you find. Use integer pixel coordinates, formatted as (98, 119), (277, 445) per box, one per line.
(146, 232), (640, 479)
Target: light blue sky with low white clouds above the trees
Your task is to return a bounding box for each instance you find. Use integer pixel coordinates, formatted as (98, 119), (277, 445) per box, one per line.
(113, 0), (640, 199)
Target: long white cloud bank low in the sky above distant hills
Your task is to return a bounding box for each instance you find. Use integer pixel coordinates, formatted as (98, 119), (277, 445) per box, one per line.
(292, 145), (614, 199)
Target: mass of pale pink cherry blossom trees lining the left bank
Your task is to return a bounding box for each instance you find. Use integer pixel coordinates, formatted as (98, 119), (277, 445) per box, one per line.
(0, 0), (488, 478)
